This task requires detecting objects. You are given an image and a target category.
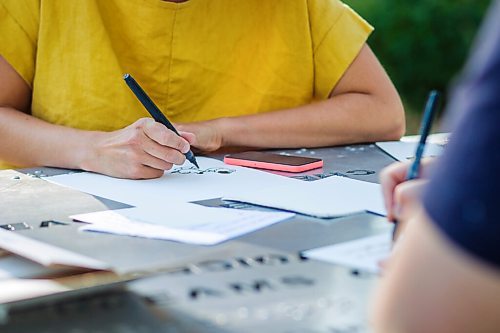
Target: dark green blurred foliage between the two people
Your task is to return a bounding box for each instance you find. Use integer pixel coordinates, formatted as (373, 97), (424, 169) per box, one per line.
(344, 0), (490, 134)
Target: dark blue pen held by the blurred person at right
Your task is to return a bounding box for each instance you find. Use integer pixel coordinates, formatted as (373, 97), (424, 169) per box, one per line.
(392, 90), (439, 240)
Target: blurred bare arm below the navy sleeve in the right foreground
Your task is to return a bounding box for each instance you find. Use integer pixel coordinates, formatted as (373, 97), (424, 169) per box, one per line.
(373, 210), (500, 333)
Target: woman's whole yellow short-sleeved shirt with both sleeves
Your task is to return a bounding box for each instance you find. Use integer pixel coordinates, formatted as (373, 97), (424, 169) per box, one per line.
(0, 0), (372, 165)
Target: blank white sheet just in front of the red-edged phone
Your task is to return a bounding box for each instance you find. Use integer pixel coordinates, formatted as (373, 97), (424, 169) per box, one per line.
(224, 176), (386, 218)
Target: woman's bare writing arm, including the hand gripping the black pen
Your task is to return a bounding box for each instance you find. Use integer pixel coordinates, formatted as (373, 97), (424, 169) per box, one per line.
(0, 56), (192, 178)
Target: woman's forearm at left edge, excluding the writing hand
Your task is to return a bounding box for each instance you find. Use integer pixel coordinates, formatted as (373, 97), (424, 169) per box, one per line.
(0, 107), (97, 168)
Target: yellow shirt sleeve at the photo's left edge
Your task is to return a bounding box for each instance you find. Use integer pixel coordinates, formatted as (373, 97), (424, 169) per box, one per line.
(0, 0), (40, 88)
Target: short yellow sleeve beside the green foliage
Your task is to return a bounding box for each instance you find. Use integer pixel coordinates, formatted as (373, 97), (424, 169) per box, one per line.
(308, 0), (373, 99)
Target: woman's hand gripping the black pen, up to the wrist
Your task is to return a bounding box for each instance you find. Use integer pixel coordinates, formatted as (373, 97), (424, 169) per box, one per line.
(80, 118), (194, 179)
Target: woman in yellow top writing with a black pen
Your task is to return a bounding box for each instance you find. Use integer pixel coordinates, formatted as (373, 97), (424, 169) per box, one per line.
(0, 0), (404, 178)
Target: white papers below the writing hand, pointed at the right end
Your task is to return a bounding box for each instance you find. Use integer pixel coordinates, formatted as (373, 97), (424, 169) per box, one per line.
(71, 203), (294, 245)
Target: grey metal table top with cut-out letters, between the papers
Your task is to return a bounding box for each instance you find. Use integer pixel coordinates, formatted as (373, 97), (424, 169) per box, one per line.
(0, 144), (394, 333)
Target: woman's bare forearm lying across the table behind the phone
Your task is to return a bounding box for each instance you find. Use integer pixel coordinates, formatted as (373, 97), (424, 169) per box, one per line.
(215, 93), (404, 148)
